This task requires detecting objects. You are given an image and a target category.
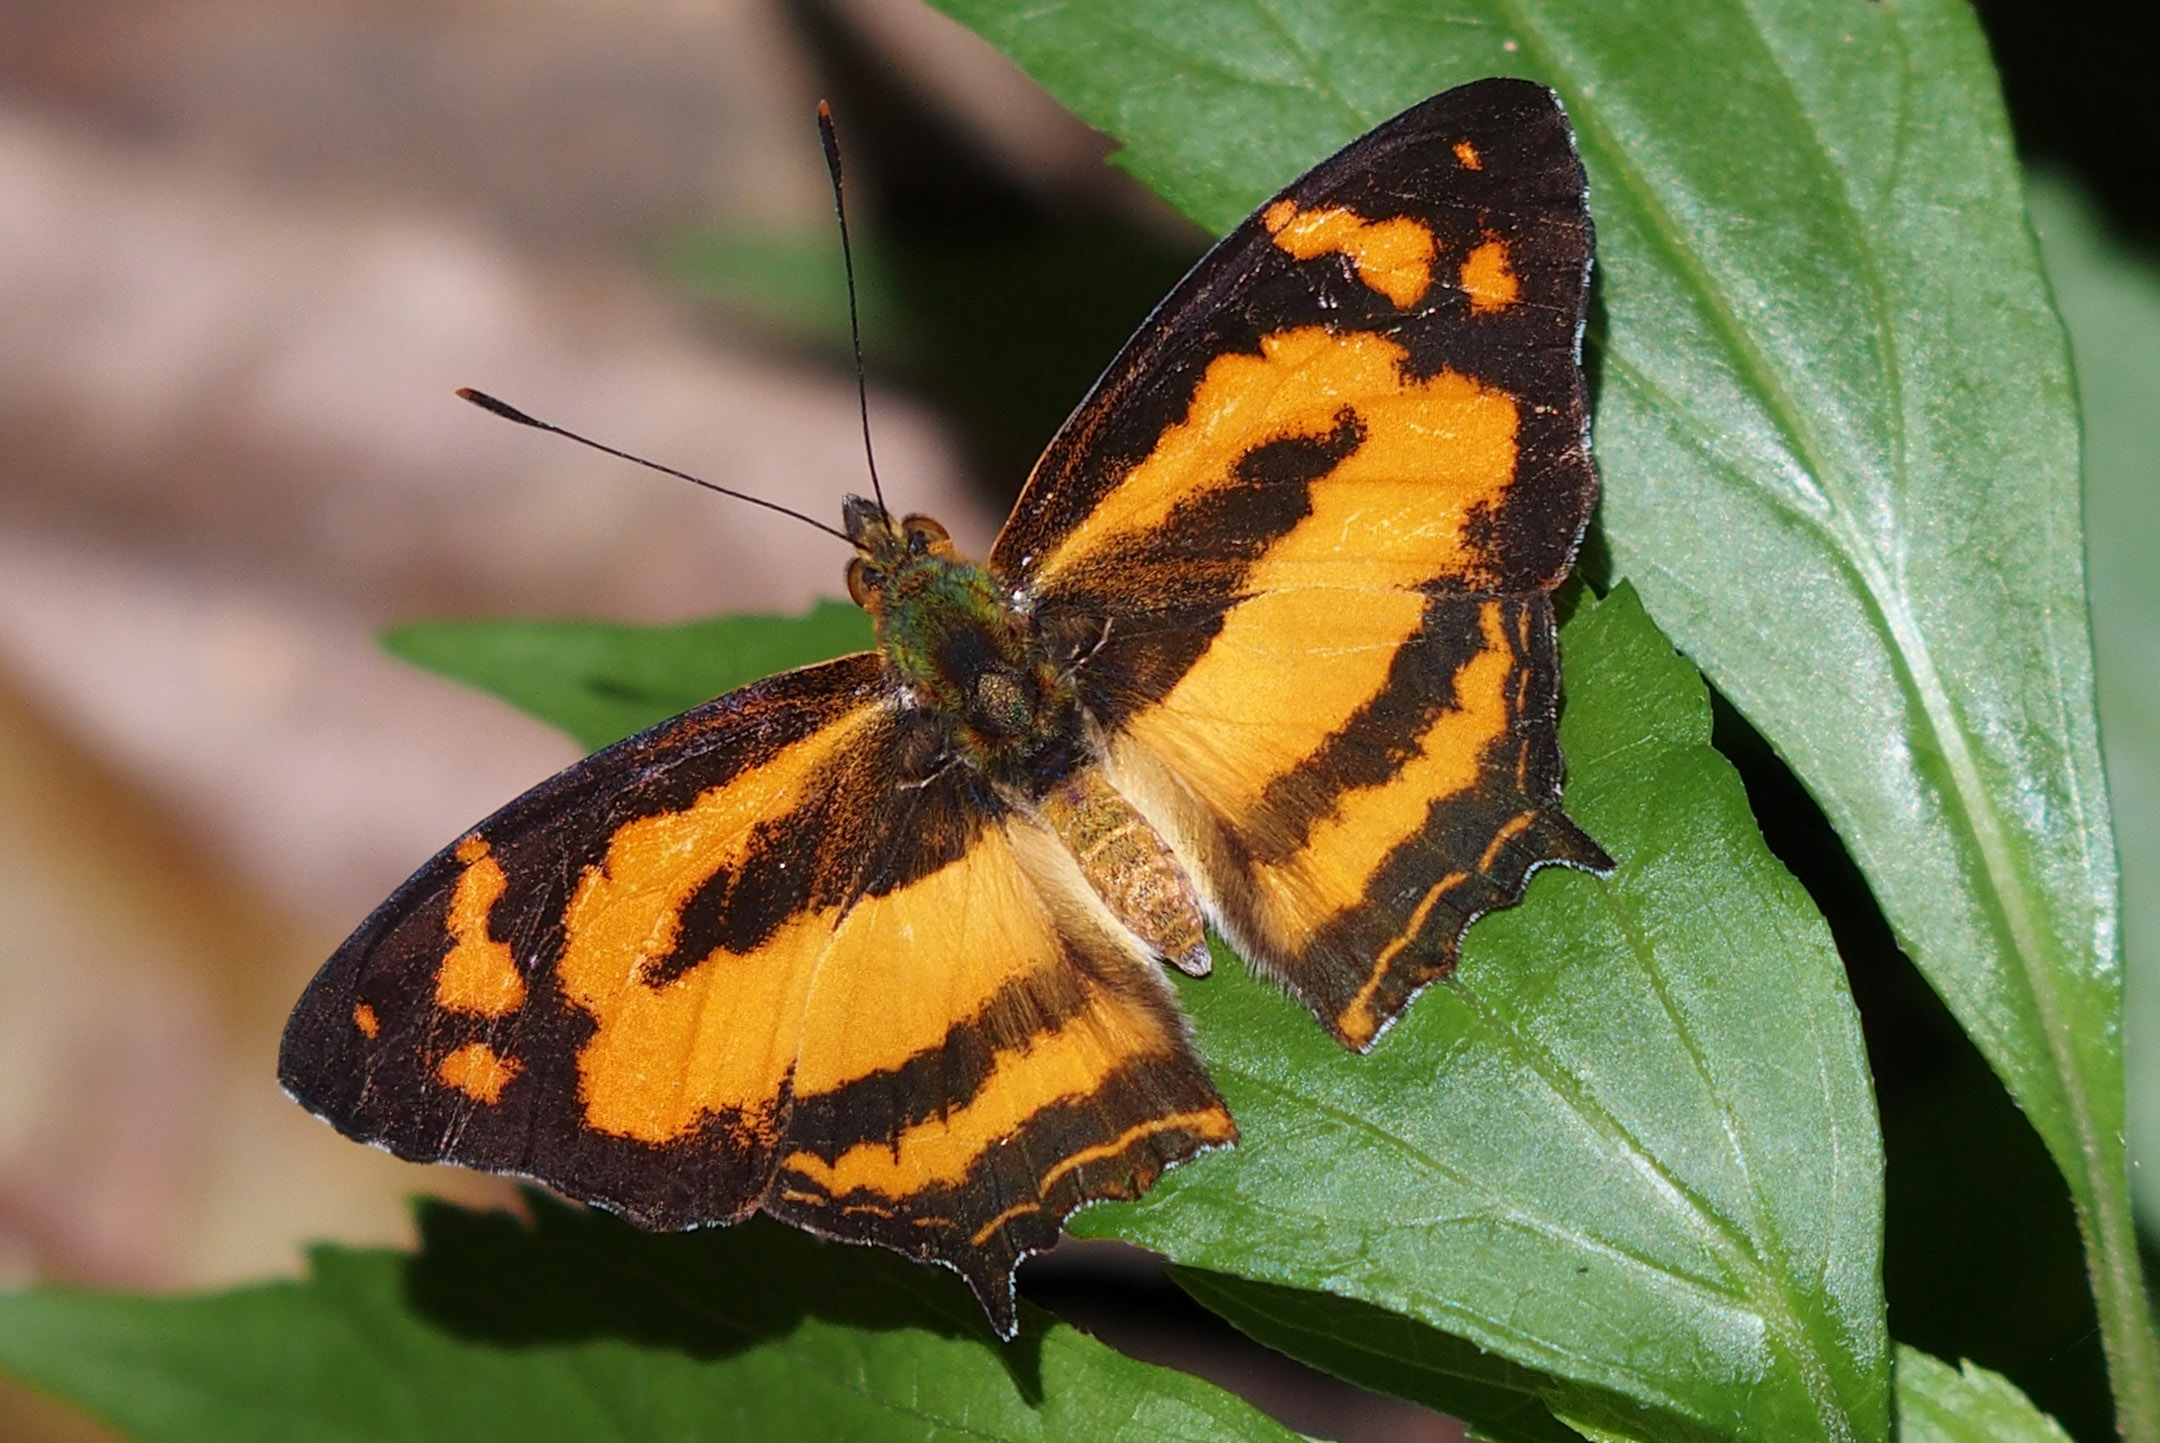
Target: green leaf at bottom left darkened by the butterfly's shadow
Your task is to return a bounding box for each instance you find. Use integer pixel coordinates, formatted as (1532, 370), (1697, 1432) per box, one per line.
(0, 1195), (1292, 1443)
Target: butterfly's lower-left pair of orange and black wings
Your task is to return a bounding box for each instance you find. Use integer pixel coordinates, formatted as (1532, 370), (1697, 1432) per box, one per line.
(279, 652), (1236, 1335)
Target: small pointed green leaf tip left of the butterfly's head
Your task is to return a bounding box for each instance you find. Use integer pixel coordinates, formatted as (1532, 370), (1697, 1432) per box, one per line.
(382, 601), (873, 747)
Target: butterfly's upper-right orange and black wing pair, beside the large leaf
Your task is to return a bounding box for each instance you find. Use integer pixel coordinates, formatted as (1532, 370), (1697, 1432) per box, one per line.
(991, 80), (1611, 1048)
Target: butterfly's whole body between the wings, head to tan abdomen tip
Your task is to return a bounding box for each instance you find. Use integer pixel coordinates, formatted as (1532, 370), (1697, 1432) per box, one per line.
(845, 497), (1207, 974)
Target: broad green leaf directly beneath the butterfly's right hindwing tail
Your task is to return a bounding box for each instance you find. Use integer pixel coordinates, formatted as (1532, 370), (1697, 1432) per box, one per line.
(1074, 590), (1890, 1443)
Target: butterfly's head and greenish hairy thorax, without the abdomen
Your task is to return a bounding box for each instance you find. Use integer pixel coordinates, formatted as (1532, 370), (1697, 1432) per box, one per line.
(842, 497), (1080, 795)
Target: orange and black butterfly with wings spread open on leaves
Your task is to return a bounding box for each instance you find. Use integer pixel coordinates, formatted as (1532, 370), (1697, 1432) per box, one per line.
(279, 80), (1611, 1335)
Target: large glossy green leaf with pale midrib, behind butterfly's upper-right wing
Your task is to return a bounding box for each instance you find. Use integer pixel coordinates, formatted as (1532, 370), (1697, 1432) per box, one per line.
(920, 0), (2160, 1437)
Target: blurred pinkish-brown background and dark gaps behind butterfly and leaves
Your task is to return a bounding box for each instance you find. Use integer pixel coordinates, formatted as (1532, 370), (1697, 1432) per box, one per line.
(0, 0), (2160, 1439)
